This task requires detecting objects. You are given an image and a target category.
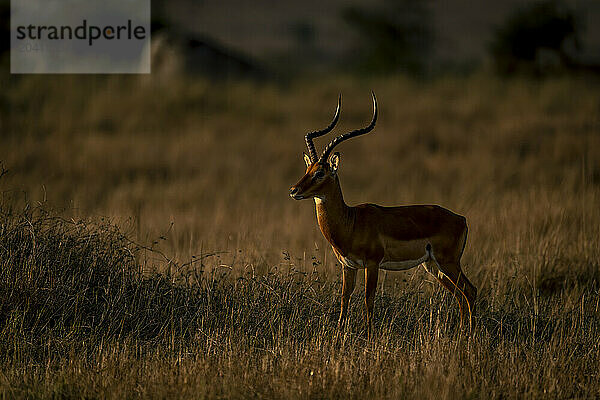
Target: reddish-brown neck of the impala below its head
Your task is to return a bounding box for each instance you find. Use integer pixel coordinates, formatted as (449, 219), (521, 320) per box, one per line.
(315, 176), (354, 253)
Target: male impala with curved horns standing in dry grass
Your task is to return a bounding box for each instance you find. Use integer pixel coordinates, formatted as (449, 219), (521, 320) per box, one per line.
(290, 93), (477, 336)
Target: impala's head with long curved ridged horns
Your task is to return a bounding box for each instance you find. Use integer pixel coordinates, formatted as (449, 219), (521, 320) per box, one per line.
(290, 92), (377, 200)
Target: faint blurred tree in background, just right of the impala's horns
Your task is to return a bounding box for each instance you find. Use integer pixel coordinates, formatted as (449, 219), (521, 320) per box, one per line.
(342, 0), (434, 74)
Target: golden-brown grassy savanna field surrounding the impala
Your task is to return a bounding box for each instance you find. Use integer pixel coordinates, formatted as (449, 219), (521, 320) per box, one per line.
(0, 73), (600, 399)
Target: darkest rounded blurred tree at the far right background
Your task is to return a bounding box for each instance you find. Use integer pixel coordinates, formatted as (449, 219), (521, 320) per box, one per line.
(489, 0), (581, 75)
